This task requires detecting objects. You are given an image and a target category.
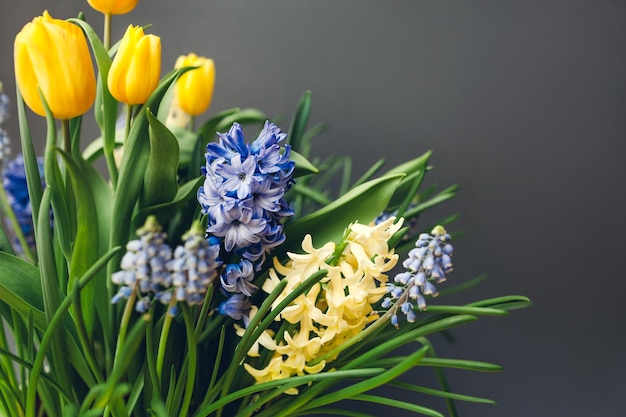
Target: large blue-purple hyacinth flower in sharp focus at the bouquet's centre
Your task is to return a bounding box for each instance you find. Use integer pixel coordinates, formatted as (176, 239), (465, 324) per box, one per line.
(198, 122), (295, 296)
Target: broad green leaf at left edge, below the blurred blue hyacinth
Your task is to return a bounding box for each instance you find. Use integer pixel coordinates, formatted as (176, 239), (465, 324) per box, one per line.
(0, 252), (46, 329)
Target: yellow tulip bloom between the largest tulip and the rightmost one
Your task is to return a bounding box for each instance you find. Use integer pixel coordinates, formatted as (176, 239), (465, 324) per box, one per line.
(108, 25), (161, 105)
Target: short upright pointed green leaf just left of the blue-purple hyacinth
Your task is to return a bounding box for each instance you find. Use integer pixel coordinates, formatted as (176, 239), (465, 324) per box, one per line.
(142, 108), (179, 207)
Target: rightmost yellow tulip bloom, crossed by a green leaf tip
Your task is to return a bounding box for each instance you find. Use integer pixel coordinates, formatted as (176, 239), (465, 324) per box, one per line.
(175, 54), (215, 116)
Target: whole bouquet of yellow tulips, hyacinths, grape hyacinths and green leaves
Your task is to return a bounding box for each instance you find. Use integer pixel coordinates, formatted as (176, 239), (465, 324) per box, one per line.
(0, 0), (528, 417)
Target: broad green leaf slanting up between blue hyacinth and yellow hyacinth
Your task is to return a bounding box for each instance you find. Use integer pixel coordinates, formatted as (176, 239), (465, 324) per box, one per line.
(277, 174), (404, 253)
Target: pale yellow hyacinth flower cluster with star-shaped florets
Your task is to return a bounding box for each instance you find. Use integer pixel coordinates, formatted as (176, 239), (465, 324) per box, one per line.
(237, 217), (402, 384)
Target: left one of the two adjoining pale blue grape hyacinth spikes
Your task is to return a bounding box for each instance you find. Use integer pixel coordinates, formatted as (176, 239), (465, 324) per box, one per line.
(111, 216), (172, 313)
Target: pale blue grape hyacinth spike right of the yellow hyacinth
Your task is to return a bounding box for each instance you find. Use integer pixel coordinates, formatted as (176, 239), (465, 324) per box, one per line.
(381, 226), (453, 327)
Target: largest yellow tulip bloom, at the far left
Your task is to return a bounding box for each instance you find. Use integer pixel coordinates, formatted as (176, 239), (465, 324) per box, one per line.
(14, 11), (96, 119)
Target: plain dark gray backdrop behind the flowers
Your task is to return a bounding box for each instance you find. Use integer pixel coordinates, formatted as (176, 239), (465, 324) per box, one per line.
(0, 0), (626, 417)
